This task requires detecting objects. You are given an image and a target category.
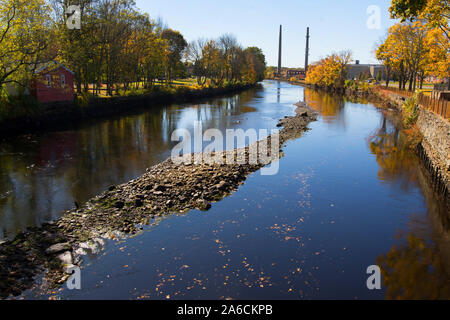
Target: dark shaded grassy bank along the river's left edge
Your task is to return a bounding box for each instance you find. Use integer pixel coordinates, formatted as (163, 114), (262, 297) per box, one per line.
(0, 84), (259, 137)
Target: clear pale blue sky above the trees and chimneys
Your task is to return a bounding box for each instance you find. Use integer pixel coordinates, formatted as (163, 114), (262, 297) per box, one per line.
(136, 0), (395, 68)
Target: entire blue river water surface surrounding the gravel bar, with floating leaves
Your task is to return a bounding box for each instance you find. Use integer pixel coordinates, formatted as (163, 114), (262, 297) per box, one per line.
(4, 81), (450, 299)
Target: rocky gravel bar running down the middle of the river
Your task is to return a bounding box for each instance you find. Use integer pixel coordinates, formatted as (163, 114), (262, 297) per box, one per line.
(0, 104), (316, 298)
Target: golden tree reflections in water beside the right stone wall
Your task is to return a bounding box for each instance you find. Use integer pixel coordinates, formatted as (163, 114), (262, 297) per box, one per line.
(368, 114), (450, 299)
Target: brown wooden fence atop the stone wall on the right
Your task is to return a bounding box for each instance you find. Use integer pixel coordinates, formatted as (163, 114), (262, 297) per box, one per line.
(377, 87), (450, 119)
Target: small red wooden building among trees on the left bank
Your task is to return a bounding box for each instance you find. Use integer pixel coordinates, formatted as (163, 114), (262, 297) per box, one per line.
(30, 61), (74, 102)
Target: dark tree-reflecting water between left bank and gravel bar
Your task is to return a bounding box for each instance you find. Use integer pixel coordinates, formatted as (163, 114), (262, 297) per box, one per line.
(0, 89), (281, 239)
